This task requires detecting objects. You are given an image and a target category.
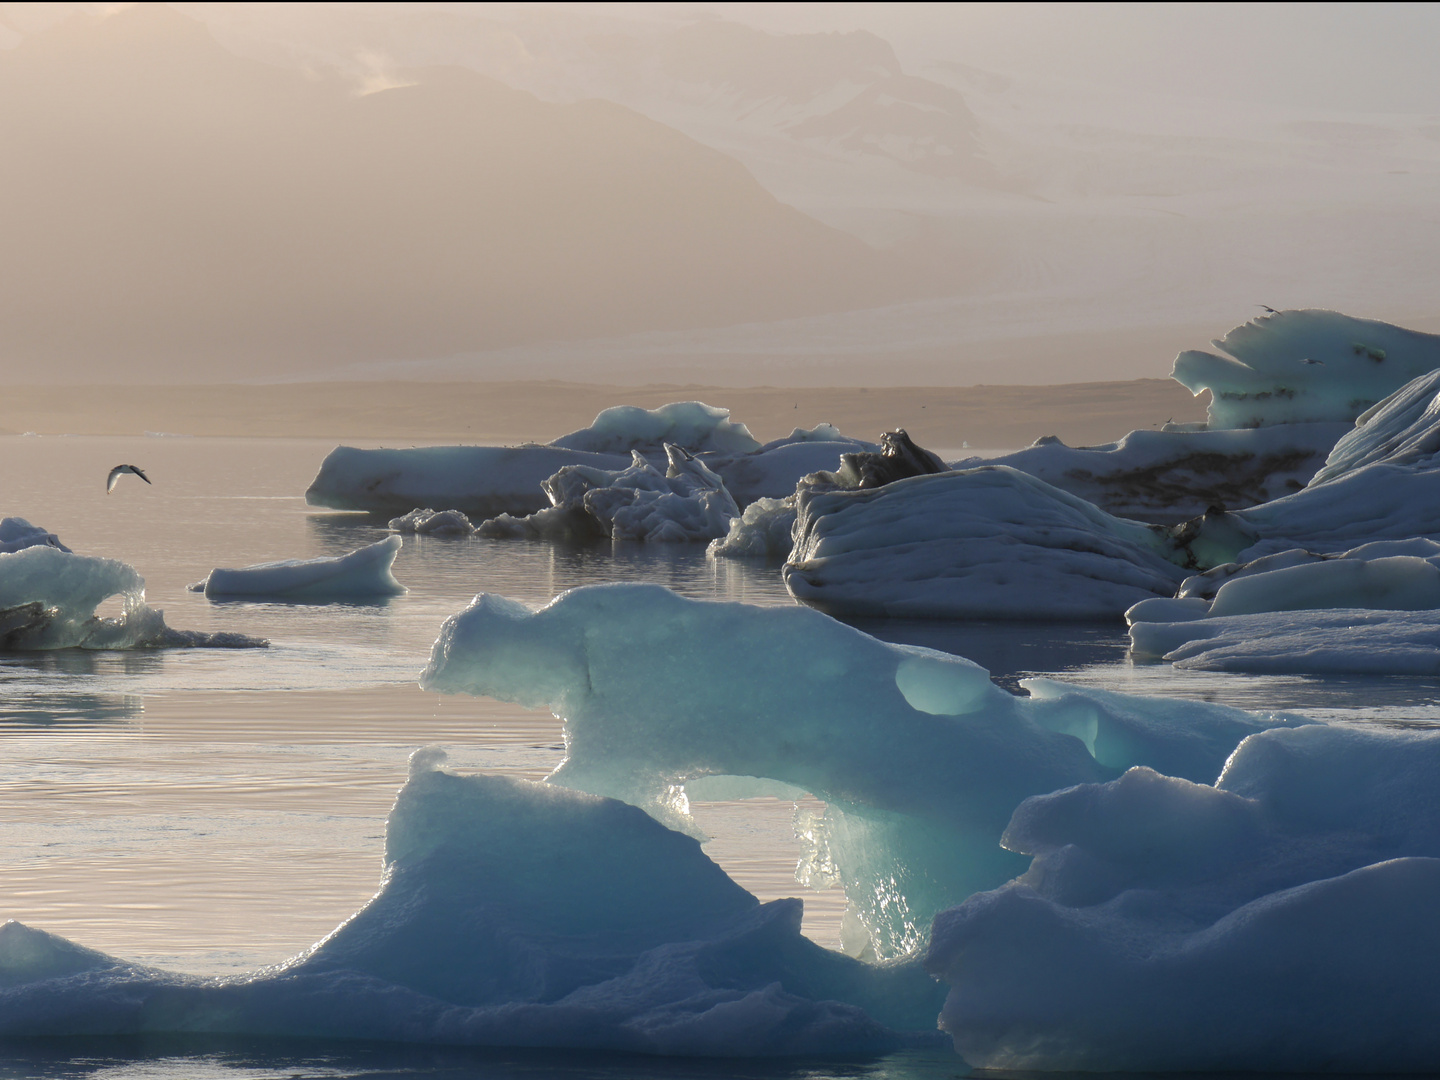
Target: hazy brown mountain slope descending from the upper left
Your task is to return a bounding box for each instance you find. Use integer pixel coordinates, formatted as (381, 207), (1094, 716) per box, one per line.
(0, 6), (907, 379)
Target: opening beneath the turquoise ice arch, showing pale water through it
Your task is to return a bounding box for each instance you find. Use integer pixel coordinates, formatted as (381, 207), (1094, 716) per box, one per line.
(685, 776), (847, 949)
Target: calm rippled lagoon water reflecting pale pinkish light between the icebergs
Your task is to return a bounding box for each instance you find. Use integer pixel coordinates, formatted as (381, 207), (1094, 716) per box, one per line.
(0, 436), (1440, 1077)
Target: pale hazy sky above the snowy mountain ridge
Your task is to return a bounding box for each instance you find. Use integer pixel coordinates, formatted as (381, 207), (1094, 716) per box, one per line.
(576, 3), (1440, 112)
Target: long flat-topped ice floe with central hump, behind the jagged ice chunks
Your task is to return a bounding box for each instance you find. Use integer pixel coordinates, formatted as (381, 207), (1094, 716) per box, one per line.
(305, 402), (873, 520)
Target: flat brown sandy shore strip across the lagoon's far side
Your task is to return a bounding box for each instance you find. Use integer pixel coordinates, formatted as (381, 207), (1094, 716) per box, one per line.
(0, 379), (1207, 449)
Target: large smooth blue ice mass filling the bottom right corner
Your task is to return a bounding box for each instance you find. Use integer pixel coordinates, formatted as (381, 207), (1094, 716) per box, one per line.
(926, 727), (1440, 1073)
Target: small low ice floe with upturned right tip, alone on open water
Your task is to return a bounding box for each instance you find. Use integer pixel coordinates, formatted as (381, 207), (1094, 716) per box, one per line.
(190, 536), (405, 600)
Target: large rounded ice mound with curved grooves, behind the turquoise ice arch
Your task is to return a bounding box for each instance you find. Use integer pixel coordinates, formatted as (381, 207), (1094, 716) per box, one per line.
(783, 465), (1185, 619)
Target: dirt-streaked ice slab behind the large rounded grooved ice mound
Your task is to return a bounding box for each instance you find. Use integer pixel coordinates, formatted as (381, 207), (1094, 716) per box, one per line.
(952, 422), (1351, 524)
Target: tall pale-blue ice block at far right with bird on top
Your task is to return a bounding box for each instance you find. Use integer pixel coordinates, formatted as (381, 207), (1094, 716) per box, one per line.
(1171, 310), (1440, 429)
